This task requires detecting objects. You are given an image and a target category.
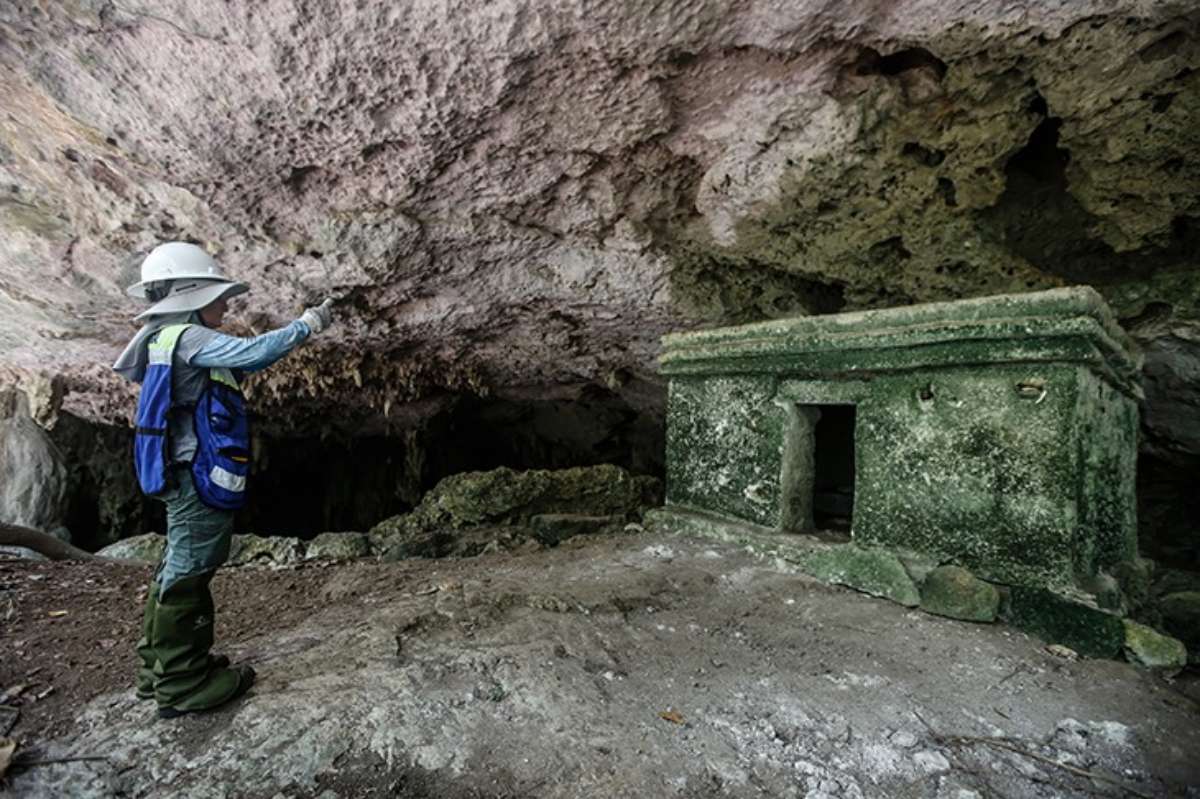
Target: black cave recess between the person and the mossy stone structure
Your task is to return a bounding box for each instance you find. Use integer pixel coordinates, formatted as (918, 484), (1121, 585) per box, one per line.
(246, 389), (665, 539)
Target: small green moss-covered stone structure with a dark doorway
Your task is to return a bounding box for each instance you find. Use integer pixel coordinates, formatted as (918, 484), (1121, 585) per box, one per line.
(661, 287), (1139, 587)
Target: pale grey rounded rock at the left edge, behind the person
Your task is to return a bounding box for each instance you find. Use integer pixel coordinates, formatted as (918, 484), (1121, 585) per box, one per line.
(0, 389), (67, 531)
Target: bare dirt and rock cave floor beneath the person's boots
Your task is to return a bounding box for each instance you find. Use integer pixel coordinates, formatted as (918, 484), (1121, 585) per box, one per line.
(0, 534), (1200, 799)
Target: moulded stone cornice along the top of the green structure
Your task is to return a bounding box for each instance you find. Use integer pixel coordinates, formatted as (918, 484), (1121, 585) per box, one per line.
(661, 287), (1141, 397)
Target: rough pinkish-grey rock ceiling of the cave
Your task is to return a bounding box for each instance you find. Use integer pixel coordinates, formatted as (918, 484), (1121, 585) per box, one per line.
(0, 0), (1200, 443)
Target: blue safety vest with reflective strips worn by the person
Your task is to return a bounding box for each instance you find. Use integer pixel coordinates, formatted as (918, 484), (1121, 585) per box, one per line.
(133, 325), (250, 510)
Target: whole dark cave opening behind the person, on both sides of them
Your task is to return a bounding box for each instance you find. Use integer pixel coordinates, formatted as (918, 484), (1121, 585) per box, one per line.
(54, 388), (665, 551)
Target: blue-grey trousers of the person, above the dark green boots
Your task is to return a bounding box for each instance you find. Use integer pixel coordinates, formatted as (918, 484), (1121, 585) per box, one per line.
(156, 464), (233, 593)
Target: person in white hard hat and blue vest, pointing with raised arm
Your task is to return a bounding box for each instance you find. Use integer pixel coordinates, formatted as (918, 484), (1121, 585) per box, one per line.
(113, 241), (332, 719)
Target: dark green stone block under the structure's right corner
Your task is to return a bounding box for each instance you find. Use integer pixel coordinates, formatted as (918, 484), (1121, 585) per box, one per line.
(1004, 585), (1124, 657)
